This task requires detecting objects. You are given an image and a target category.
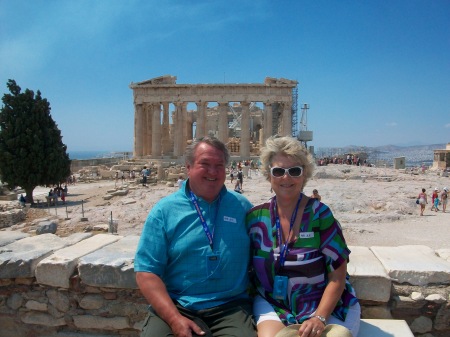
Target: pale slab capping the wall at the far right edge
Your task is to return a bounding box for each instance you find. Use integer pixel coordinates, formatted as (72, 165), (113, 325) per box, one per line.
(370, 245), (450, 286)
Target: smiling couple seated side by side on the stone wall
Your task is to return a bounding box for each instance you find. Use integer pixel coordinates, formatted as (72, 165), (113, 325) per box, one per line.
(134, 137), (361, 337)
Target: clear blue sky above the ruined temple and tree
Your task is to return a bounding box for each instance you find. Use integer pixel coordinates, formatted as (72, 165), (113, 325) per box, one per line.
(0, 0), (450, 152)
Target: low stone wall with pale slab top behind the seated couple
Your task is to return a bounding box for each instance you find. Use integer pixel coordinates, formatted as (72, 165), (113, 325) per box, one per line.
(0, 231), (450, 337)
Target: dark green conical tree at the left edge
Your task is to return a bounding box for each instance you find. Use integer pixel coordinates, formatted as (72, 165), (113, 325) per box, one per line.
(0, 80), (70, 203)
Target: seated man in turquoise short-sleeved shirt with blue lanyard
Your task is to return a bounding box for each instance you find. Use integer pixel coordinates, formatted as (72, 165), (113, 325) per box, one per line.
(134, 137), (256, 337)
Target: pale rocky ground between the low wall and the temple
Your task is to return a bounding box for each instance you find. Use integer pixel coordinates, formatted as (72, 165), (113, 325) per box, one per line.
(8, 165), (450, 249)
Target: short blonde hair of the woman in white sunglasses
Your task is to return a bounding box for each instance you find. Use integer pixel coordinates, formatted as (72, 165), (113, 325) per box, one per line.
(260, 136), (314, 186)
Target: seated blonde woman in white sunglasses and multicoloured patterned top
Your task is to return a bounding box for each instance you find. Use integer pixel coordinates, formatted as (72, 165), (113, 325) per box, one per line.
(247, 137), (361, 337)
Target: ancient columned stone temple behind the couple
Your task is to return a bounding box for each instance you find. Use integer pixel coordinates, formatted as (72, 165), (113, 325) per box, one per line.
(129, 75), (298, 159)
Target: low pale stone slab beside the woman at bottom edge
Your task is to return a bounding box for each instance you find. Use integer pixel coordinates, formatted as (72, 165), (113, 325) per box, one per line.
(358, 319), (414, 337)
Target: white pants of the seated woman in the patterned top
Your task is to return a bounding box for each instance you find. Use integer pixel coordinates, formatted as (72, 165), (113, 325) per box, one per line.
(253, 295), (361, 337)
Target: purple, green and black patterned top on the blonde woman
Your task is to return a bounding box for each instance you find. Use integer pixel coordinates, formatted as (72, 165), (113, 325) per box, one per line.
(247, 193), (358, 325)
